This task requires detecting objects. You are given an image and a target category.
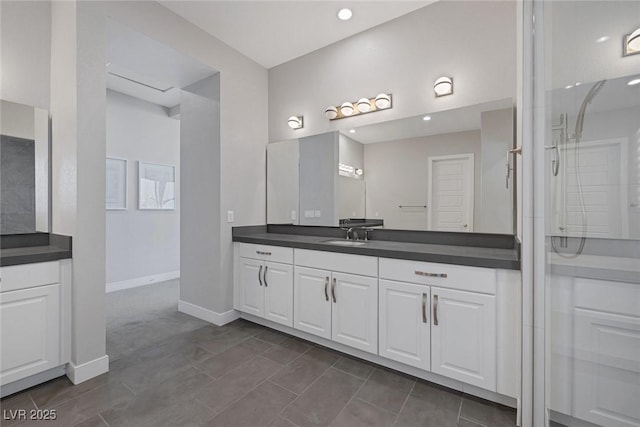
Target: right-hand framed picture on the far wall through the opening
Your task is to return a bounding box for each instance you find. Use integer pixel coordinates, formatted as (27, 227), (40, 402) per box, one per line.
(138, 161), (176, 210)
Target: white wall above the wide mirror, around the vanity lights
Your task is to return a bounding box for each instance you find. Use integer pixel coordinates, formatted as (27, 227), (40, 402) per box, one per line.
(269, 1), (517, 141)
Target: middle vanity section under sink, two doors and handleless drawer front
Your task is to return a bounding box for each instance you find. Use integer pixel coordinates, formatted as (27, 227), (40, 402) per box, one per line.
(293, 249), (378, 353)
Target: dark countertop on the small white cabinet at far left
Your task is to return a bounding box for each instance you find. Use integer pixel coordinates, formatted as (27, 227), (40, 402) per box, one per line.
(0, 233), (72, 267)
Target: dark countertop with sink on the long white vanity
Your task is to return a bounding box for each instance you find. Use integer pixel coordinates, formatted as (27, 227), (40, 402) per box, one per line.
(233, 229), (520, 270)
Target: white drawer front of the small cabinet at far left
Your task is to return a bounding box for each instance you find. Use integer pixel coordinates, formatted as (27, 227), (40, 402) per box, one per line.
(0, 261), (60, 292)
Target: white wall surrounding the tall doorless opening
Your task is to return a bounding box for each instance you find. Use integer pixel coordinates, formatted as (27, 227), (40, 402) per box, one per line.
(47, 1), (268, 372)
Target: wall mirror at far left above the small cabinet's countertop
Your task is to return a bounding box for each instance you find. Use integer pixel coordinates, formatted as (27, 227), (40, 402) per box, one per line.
(0, 100), (49, 235)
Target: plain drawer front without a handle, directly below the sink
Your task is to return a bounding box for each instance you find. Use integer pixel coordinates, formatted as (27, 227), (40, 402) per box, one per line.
(295, 249), (378, 277)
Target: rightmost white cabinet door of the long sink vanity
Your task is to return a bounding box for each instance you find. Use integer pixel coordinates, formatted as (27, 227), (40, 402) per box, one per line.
(431, 287), (496, 391)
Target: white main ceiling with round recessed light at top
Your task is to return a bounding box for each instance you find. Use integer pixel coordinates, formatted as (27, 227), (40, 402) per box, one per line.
(160, 0), (434, 68)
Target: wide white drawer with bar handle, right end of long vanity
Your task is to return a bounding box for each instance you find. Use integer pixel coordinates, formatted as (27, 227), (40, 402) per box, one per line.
(380, 258), (496, 295)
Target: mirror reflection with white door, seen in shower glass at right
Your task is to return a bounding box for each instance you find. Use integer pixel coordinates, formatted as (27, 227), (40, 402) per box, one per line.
(546, 75), (640, 242)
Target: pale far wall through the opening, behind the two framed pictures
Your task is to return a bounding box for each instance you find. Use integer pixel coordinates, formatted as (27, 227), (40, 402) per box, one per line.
(106, 91), (181, 284)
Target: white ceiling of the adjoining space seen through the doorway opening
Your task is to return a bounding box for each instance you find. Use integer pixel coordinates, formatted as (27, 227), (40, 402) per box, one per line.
(106, 21), (217, 107)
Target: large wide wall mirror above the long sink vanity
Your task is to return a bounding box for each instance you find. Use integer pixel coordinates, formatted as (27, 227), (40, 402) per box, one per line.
(267, 99), (515, 234)
